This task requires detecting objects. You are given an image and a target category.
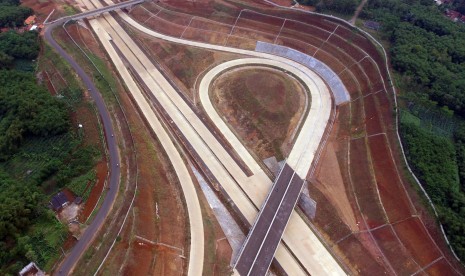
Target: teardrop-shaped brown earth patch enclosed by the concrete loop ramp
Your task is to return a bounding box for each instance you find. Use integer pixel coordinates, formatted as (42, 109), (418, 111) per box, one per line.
(210, 66), (309, 160)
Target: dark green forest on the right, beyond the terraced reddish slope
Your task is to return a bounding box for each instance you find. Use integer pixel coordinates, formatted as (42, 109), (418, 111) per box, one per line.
(361, 0), (465, 260)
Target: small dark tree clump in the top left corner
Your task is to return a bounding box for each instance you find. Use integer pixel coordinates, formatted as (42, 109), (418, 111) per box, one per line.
(0, 0), (32, 27)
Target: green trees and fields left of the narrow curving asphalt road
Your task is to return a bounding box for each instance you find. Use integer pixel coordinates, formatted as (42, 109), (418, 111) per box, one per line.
(0, 18), (98, 275)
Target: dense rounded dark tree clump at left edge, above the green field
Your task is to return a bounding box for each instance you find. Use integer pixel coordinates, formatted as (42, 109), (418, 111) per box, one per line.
(0, 70), (69, 157)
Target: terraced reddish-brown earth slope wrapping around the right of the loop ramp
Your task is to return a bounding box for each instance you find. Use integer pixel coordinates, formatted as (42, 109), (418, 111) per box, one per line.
(123, 1), (462, 273)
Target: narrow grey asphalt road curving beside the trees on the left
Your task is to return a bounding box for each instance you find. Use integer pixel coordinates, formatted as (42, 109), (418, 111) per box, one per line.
(44, 22), (121, 275)
